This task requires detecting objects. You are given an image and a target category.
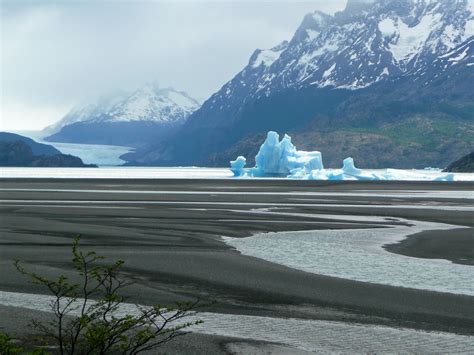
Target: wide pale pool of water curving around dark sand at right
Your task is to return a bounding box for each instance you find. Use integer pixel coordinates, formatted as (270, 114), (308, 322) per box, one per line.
(223, 220), (474, 295)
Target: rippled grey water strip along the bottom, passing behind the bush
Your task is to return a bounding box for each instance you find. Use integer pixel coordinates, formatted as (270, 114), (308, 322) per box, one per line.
(0, 291), (474, 354)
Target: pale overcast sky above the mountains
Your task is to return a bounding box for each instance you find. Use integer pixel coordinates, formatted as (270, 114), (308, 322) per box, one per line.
(0, 0), (346, 130)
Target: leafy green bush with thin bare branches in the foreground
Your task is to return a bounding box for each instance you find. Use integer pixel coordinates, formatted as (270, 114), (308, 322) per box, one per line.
(13, 237), (202, 354)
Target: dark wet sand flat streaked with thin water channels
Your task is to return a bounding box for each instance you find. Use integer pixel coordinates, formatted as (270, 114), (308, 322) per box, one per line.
(0, 179), (474, 352)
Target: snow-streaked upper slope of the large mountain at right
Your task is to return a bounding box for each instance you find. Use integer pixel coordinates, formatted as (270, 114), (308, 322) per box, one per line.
(203, 0), (474, 115)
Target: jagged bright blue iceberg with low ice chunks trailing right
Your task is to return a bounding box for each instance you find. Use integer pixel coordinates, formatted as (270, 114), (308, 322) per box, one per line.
(230, 131), (456, 181)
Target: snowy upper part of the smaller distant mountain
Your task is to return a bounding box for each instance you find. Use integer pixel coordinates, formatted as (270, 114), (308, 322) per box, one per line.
(46, 84), (199, 132)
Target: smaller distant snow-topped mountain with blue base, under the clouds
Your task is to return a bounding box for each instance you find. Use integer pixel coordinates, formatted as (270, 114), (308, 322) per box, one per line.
(45, 83), (199, 144)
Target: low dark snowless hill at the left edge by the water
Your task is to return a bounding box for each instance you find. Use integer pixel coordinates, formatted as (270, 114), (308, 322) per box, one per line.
(0, 132), (95, 168)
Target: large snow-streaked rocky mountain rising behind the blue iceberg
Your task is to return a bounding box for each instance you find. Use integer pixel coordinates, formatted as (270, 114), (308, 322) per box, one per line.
(134, 0), (474, 167)
